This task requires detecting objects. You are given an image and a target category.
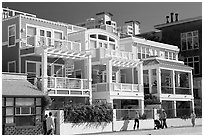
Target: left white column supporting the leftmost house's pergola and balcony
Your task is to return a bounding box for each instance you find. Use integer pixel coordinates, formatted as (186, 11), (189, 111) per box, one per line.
(41, 49), (48, 94)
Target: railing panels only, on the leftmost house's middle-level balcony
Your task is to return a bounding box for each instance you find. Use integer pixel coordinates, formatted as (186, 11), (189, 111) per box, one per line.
(48, 77), (89, 89)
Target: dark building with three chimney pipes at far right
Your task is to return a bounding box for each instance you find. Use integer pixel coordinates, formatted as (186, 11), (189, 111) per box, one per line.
(154, 13), (202, 108)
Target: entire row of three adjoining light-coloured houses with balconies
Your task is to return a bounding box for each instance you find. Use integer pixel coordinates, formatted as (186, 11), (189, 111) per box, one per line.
(2, 9), (194, 119)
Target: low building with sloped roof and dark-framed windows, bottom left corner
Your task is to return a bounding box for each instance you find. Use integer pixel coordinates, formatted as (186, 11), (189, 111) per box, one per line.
(2, 73), (46, 135)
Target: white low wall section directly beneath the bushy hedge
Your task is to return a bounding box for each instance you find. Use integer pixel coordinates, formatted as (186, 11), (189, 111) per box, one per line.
(60, 123), (112, 135)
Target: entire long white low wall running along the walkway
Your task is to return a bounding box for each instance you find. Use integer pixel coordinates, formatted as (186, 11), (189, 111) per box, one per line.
(46, 110), (202, 135)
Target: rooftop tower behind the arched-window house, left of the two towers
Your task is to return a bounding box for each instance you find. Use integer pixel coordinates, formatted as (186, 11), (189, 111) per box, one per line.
(77, 12), (117, 35)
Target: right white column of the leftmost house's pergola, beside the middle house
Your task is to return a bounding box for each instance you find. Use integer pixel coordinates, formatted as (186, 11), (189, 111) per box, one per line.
(87, 55), (92, 104)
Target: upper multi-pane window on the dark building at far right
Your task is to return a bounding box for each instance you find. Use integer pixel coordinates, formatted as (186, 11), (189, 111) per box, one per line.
(181, 31), (199, 50)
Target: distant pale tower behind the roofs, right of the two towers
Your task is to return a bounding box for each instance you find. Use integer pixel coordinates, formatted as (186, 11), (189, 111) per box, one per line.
(118, 20), (140, 38)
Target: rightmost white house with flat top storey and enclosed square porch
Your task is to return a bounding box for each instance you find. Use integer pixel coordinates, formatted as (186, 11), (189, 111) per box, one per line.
(120, 37), (194, 117)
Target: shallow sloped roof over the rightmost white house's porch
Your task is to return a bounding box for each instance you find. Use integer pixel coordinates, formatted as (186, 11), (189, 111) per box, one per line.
(143, 58), (193, 71)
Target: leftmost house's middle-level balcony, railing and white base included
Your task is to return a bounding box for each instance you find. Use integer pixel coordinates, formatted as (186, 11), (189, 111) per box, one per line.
(47, 77), (90, 95)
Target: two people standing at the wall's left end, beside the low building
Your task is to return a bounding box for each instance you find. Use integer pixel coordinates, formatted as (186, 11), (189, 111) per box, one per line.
(43, 112), (55, 135)
